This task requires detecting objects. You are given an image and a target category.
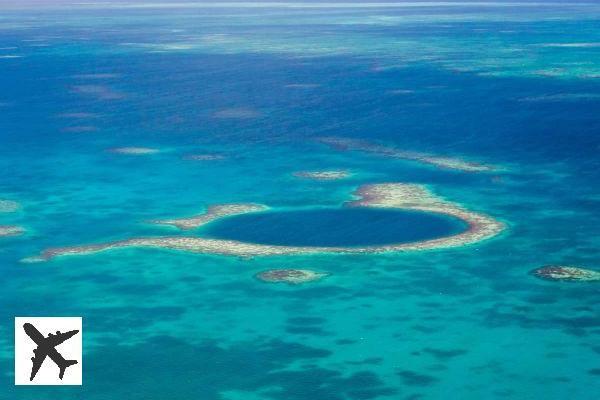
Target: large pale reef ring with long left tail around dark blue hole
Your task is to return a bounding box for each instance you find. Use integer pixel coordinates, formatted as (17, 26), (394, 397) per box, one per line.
(27, 183), (505, 262)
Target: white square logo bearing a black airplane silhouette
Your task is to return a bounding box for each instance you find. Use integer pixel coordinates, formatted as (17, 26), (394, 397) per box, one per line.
(15, 317), (83, 385)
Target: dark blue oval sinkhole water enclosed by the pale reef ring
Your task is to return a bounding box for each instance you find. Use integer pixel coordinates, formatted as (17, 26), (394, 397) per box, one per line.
(203, 207), (467, 247)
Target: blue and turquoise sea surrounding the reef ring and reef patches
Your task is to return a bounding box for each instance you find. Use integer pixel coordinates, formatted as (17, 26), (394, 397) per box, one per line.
(0, 1), (600, 400)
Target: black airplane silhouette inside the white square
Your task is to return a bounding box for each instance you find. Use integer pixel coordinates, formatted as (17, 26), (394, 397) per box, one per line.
(23, 323), (79, 381)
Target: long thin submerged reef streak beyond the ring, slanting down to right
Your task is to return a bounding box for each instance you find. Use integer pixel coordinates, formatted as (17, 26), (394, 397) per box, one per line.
(319, 137), (498, 172)
